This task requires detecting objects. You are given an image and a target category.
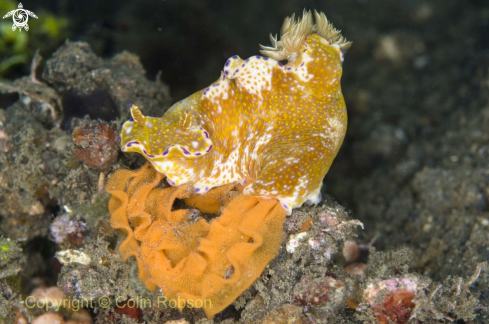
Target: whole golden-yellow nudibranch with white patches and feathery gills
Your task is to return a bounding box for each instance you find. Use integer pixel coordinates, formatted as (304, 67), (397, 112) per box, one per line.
(121, 11), (351, 214)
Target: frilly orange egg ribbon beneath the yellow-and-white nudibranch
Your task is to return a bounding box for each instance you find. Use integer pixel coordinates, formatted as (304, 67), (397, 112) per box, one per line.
(106, 164), (285, 318)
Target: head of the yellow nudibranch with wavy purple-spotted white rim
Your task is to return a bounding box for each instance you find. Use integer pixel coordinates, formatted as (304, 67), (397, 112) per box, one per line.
(121, 105), (212, 182)
